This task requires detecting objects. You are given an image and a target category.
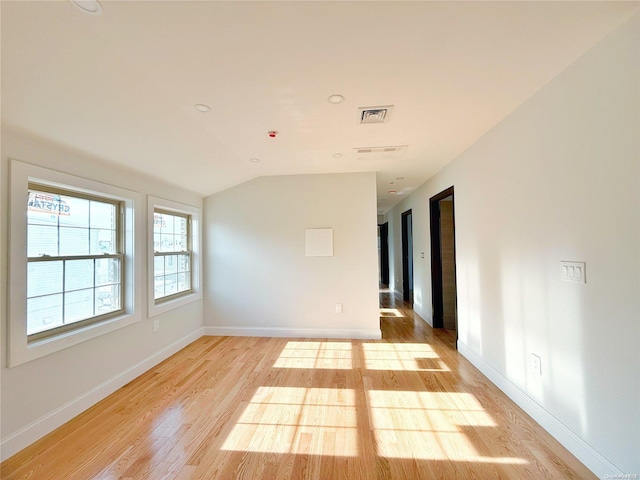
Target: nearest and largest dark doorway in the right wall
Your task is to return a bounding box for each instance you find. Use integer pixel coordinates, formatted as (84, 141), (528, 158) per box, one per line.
(429, 187), (458, 339)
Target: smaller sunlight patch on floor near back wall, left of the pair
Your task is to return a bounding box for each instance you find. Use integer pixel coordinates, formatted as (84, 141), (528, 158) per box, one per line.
(273, 341), (352, 369)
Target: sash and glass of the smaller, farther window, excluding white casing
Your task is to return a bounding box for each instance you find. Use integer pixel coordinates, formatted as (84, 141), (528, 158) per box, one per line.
(153, 210), (191, 301)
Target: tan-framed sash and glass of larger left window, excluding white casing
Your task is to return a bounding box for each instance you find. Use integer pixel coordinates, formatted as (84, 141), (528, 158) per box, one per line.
(27, 184), (124, 340)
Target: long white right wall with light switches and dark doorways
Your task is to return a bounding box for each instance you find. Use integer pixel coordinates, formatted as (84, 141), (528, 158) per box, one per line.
(386, 16), (640, 477)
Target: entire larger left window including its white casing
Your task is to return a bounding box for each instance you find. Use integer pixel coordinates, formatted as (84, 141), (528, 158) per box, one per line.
(7, 160), (145, 367)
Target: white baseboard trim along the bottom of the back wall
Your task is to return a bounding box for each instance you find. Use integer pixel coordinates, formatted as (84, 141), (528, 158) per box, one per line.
(204, 326), (382, 340)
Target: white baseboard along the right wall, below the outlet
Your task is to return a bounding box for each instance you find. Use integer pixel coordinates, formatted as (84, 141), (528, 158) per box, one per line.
(458, 340), (624, 478)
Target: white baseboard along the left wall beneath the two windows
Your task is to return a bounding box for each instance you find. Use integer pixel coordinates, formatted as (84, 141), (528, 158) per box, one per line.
(0, 328), (203, 461)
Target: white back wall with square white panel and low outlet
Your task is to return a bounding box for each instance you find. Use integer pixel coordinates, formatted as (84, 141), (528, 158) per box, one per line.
(204, 173), (380, 338)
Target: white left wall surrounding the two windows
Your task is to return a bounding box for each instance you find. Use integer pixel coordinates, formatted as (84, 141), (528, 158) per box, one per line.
(0, 127), (202, 459)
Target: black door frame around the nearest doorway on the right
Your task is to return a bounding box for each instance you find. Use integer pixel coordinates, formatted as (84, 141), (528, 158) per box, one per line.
(429, 186), (458, 330)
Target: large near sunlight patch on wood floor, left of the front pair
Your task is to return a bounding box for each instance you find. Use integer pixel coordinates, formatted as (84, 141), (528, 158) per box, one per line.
(222, 387), (358, 457)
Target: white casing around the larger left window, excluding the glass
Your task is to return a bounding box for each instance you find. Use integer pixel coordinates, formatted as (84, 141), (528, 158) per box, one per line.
(7, 159), (144, 367)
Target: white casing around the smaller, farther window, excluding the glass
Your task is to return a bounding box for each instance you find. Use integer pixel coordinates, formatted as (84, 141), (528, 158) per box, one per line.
(147, 195), (202, 318)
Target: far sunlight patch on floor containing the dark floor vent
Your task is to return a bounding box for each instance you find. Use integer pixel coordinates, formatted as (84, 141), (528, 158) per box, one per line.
(362, 343), (450, 372)
